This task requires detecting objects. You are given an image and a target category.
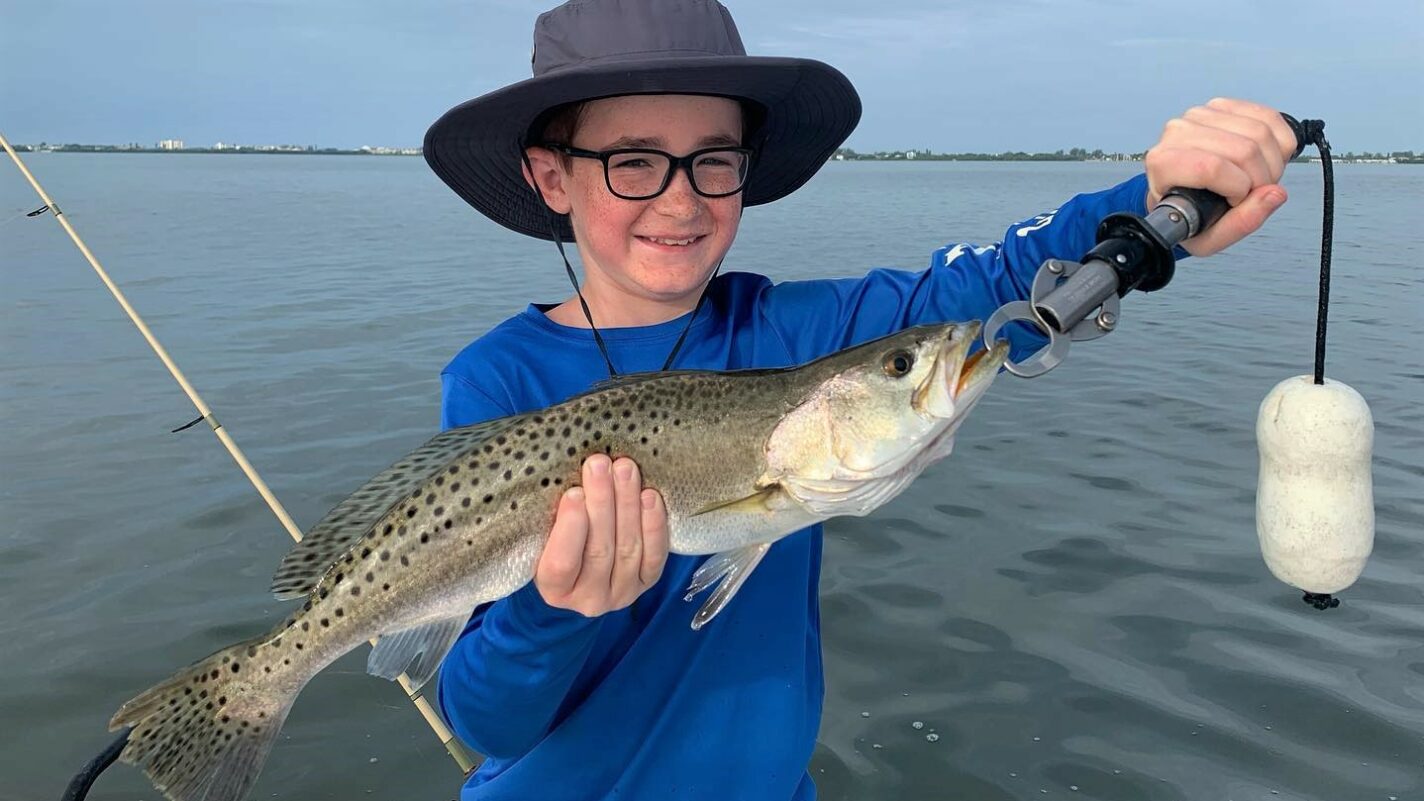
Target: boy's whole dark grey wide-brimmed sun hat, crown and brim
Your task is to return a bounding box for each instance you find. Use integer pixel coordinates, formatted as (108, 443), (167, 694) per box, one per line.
(424, 0), (860, 241)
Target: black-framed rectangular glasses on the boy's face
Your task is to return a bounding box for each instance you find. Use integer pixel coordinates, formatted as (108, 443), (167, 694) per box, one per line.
(540, 143), (752, 200)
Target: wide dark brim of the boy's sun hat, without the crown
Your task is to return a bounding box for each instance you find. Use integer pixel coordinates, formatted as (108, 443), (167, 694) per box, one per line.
(424, 56), (860, 241)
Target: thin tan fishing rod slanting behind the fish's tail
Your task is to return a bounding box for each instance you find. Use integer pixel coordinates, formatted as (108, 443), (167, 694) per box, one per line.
(0, 134), (474, 801)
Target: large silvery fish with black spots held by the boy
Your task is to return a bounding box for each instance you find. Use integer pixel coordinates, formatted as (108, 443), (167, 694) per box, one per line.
(110, 322), (1008, 801)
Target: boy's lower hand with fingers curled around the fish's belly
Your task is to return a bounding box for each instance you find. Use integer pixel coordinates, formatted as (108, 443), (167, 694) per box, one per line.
(534, 453), (668, 617)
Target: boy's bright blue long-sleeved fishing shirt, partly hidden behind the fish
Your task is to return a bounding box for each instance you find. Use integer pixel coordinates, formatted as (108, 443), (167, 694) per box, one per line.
(437, 175), (1146, 801)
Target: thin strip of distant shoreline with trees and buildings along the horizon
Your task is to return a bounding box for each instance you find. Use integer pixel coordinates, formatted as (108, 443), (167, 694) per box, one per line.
(13, 144), (1424, 164)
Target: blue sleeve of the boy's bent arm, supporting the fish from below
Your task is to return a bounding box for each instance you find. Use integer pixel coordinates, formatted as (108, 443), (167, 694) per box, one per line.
(436, 372), (600, 758)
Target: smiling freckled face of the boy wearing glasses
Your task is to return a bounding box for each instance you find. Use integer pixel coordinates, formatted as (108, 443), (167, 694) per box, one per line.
(531, 94), (742, 316)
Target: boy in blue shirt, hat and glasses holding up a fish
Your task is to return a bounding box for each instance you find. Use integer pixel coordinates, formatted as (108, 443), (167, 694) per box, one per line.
(424, 0), (1294, 801)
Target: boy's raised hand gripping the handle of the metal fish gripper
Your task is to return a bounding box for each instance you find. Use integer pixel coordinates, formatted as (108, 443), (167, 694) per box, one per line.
(1143, 97), (1296, 257)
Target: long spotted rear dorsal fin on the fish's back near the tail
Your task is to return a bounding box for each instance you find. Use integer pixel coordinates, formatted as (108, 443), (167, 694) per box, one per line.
(272, 415), (524, 600)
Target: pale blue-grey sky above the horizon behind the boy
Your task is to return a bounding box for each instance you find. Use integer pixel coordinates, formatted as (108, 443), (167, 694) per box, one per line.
(0, 0), (1424, 151)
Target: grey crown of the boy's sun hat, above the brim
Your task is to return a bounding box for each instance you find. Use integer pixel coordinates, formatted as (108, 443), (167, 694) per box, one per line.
(534, 0), (746, 77)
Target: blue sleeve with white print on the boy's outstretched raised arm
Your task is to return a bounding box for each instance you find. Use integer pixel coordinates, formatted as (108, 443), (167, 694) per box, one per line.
(762, 175), (1150, 362)
